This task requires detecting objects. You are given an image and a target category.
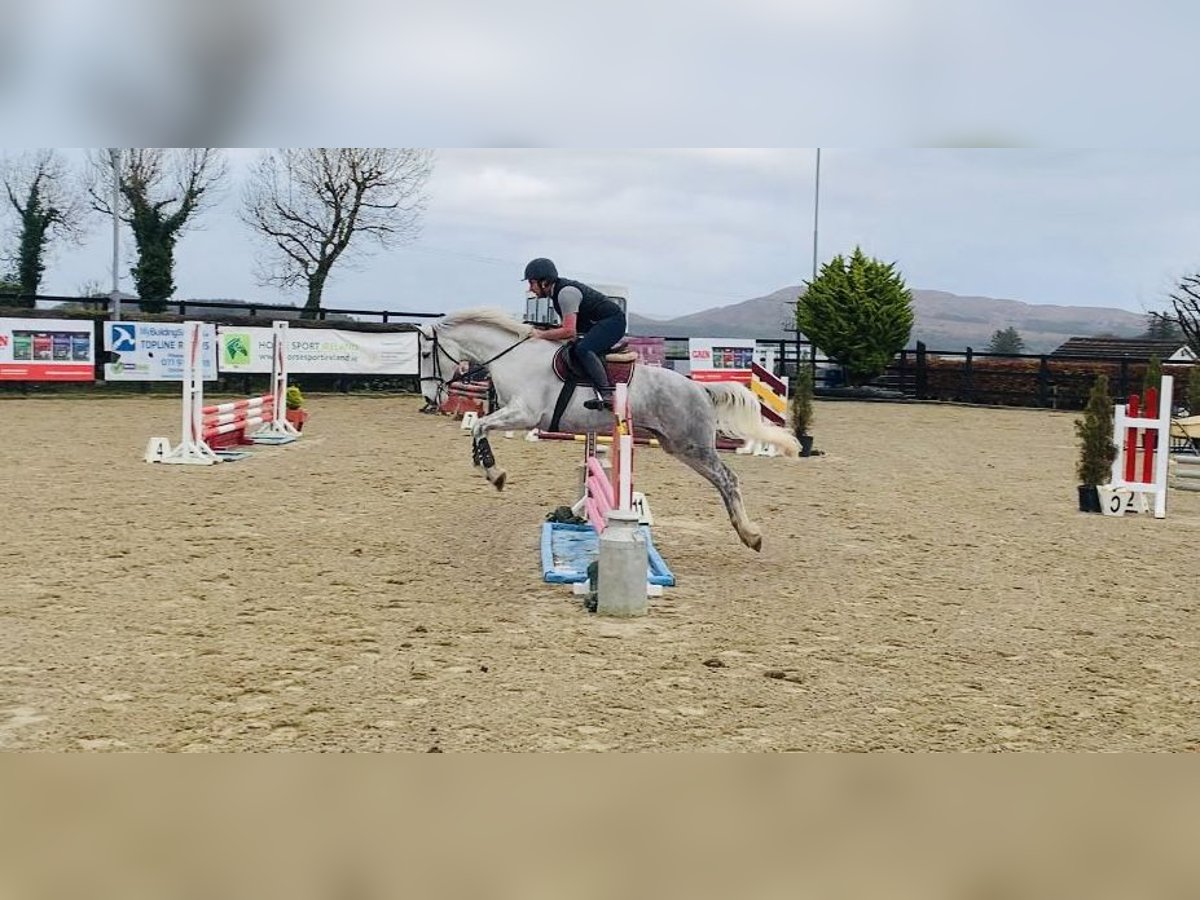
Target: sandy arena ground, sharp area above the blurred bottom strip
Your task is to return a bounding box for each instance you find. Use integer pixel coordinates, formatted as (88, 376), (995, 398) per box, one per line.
(0, 396), (1200, 751)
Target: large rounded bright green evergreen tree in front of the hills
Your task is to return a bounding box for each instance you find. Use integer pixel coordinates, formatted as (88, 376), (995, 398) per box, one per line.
(796, 247), (913, 385)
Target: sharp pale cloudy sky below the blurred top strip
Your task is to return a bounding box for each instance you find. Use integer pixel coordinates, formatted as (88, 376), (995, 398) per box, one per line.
(7, 149), (1200, 317)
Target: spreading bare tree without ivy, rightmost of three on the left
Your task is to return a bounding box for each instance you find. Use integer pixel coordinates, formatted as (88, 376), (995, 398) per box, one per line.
(242, 146), (433, 311)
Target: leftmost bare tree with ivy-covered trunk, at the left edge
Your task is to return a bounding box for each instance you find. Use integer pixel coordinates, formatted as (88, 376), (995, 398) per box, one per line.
(0, 150), (88, 306)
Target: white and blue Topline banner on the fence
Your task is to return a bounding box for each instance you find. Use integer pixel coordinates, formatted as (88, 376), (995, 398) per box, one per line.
(104, 322), (217, 382)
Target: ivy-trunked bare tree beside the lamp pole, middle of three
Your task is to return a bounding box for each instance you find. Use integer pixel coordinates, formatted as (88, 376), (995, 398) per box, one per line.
(89, 148), (227, 312)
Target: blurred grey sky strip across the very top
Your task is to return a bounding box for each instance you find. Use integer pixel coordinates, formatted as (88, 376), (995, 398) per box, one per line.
(0, 0), (1200, 148)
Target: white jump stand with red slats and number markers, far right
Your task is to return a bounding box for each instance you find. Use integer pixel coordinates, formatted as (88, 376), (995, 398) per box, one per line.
(1100, 376), (1175, 518)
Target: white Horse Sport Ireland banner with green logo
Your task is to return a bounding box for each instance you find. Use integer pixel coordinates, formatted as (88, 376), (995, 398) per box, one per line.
(218, 325), (419, 374)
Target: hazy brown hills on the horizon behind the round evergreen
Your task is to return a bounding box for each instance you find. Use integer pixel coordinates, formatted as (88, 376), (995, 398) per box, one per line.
(629, 284), (1146, 353)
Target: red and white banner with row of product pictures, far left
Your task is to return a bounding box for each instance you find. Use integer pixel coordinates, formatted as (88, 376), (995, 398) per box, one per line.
(0, 319), (96, 382)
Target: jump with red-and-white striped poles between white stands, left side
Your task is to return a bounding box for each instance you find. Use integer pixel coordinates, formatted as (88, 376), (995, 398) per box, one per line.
(145, 322), (299, 466)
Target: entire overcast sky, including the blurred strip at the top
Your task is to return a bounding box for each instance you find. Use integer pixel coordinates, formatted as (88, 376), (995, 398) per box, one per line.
(0, 0), (1200, 316)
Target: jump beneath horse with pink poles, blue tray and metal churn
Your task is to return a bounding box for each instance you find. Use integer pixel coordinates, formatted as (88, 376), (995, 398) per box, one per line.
(541, 383), (674, 616)
